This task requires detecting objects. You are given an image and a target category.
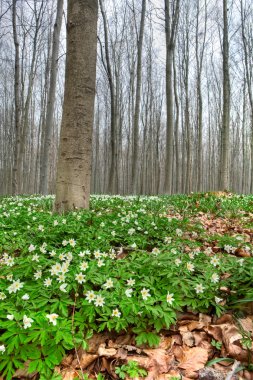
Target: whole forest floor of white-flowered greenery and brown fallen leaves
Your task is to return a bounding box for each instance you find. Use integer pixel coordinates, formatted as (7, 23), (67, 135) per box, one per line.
(0, 192), (253, 380)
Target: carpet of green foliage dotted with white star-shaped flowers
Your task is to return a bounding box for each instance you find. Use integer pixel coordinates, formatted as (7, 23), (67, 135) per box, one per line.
(0, 193), (253, 379)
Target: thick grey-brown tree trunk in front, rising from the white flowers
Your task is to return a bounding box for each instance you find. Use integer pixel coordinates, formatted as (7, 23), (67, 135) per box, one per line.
(55, 0), (98, 213)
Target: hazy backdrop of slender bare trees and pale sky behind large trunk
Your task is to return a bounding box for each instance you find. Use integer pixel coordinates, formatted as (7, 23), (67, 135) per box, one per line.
(0, 0), (253, 194)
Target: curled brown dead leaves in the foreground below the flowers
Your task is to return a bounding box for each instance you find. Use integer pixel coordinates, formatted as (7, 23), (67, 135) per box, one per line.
(49, 313), (253, 380)
